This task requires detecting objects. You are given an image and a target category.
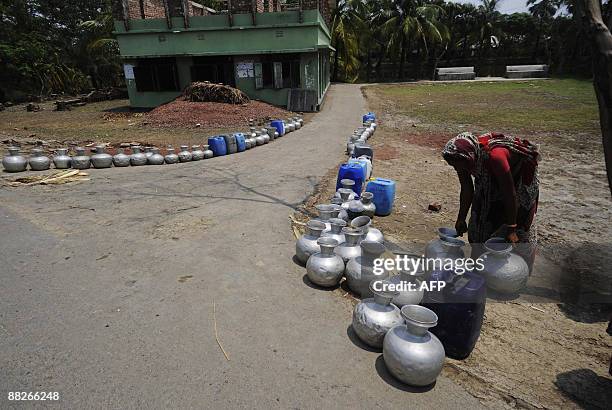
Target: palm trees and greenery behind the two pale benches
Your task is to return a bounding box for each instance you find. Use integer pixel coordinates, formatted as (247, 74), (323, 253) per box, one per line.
(332, 0), (590, 81)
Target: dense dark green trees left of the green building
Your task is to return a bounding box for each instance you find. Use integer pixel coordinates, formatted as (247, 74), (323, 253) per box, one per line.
(0, 0), (120, 100)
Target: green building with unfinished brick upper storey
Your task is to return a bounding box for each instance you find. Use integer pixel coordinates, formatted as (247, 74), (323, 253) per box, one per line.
(114, 0), (334, 111)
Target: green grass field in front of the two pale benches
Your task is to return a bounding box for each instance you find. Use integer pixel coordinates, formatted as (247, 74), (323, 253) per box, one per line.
(366, 79), (599, 134)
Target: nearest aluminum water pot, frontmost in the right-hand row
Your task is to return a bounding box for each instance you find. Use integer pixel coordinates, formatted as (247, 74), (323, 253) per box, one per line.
(383, 305), (444, 386)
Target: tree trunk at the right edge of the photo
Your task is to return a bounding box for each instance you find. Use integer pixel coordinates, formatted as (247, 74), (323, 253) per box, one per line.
(576, 0), (612, 194)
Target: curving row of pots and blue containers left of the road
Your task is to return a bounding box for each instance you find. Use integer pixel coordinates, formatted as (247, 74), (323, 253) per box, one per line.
(2, 117), (304, 172)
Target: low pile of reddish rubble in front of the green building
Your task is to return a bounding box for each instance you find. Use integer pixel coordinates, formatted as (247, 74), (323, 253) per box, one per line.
(144, 100), (291, 127)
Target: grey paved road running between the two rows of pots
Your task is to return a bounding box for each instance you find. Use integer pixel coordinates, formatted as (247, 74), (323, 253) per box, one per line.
(0, 85), (478, 408)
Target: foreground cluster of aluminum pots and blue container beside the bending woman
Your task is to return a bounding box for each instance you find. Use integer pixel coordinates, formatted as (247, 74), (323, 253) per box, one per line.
(296, 113), (529, 386)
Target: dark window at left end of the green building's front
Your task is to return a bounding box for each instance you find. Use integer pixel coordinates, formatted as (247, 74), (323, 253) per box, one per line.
(134, 58), (179, 92)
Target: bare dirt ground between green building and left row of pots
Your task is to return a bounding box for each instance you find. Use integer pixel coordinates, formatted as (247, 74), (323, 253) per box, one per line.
(0, 100), (304, 154)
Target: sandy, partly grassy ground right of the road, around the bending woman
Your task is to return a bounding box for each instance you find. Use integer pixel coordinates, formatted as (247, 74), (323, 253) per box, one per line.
(297, 81), (612, 408)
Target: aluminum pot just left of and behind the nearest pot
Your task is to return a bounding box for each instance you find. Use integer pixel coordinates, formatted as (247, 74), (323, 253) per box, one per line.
(352, 280), (404, 349)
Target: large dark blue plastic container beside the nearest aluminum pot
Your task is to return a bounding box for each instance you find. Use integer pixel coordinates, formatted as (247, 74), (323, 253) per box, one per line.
(422, 271), (487, 360)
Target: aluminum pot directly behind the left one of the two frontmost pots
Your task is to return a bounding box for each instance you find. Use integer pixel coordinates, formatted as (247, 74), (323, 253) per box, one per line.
(344, 241), (389, 297)
